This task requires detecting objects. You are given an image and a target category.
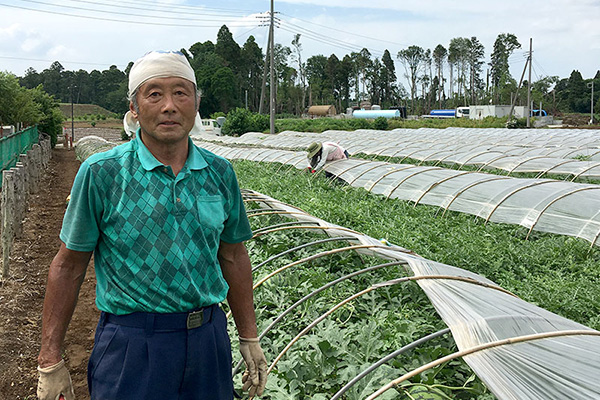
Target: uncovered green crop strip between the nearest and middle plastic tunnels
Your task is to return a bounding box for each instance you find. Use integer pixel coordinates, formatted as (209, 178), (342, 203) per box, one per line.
(234, 161), (600, 329)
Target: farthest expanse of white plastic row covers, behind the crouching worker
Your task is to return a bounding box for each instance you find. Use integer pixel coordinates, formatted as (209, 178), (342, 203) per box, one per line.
(193, 128), (600, 179)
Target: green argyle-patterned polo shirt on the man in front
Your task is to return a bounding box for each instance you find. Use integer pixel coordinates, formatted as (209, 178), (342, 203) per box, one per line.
(60, 134), (252, 314)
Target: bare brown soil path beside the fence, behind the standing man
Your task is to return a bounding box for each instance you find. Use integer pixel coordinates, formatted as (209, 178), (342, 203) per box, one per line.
(0, 128), (120, 400)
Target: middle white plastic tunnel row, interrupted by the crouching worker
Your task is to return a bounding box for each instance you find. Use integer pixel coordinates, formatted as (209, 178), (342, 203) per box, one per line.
(193, 142), (600, 245)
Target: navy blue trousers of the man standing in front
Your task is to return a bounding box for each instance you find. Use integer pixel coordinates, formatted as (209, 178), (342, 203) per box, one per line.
(88, 305), (233, 400)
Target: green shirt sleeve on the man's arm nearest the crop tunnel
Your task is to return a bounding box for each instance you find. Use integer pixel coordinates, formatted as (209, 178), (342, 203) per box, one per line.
(221, 167), (252, 243)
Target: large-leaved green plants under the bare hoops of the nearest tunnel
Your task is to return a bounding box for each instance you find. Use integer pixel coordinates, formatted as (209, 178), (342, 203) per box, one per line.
(231, 203), (493, 400)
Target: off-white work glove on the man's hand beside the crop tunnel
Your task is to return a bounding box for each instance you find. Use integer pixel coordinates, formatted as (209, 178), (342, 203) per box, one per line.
(240, 337), (267, 398)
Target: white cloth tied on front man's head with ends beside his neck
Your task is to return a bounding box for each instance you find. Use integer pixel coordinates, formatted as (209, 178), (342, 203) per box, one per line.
(123, 51), (204, 137)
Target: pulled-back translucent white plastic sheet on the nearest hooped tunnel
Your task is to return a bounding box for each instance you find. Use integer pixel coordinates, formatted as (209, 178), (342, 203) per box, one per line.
(246, 193), (600, 400)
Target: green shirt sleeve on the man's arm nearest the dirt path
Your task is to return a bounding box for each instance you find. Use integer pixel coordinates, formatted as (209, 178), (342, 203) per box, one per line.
(60, 162), (102, 251)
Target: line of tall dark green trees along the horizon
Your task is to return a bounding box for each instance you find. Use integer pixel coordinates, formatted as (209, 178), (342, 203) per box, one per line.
(11, 25), (600, 116)
